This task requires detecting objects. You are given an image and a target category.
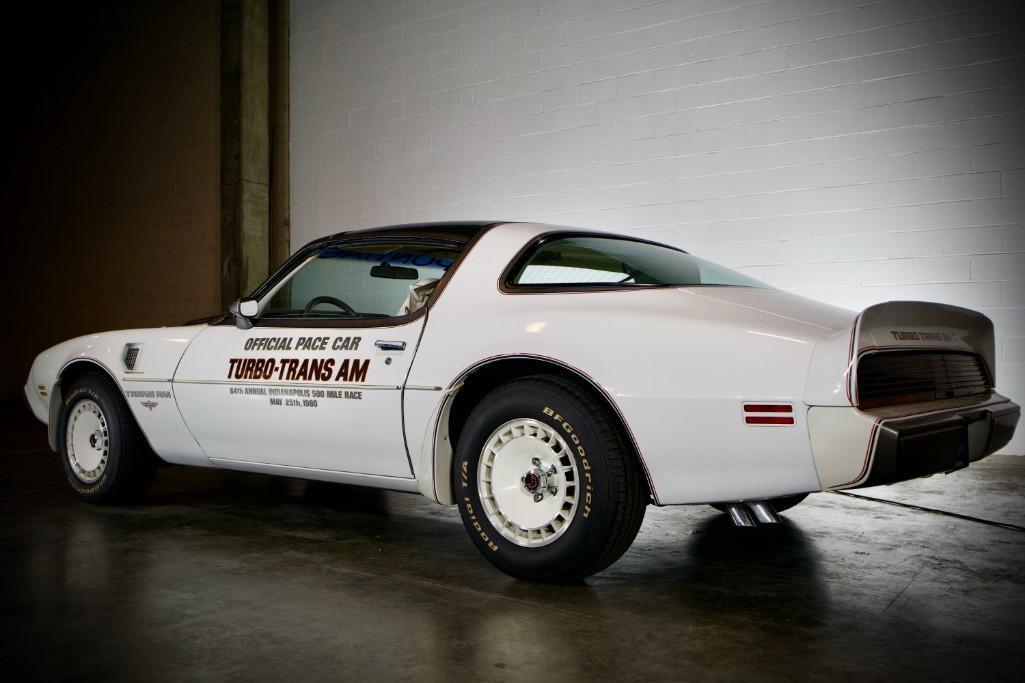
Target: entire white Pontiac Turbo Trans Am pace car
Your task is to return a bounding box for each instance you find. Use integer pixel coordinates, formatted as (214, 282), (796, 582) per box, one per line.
(25, 223), (1020, 581)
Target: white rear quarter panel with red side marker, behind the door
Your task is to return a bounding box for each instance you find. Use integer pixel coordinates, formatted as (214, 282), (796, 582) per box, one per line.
(405, 226), (840, 504)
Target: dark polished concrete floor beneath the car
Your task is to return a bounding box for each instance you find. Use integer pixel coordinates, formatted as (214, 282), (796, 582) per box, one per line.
(0, 410), (1025, 681)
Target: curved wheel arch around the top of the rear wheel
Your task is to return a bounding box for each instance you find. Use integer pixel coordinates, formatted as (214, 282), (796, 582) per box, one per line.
(433, 354), (658, 505)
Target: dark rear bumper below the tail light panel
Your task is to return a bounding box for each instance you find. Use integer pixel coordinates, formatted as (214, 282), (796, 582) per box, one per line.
(858, 394), (1021, 487)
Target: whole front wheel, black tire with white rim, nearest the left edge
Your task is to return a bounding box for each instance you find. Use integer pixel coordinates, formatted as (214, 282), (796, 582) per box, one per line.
(57, 373), (158, 503)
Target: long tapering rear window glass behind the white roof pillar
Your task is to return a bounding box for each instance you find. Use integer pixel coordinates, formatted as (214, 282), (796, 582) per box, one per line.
(507, 236), (769, 289)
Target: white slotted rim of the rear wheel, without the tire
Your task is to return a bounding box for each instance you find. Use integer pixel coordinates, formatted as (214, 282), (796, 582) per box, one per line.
(477, 418), (580, 548)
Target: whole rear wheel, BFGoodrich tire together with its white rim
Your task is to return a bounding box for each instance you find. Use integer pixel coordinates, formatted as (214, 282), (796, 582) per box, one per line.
(453, 376), (649, 582)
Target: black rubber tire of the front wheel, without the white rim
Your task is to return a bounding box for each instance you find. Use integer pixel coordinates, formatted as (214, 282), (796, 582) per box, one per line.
(57, 373), (158, 504)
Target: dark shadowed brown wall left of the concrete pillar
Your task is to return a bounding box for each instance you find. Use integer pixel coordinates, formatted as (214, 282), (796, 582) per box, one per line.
(6, 0), (219, 404)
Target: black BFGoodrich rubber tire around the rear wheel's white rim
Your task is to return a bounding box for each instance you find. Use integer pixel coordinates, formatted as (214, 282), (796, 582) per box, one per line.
(452, 375), (649, 582)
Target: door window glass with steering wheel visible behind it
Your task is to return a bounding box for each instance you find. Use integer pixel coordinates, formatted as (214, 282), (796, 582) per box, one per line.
(260, 242), (459, 318)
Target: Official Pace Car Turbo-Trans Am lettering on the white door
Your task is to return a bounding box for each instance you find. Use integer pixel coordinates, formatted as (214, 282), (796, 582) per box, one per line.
(228, 336), (370, 408)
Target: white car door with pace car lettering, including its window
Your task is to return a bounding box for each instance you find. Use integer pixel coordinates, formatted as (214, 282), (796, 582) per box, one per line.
(172, 238), (459, 478)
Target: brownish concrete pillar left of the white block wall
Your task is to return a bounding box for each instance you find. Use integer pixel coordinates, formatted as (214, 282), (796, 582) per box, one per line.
(220, 0), (271, 308)
